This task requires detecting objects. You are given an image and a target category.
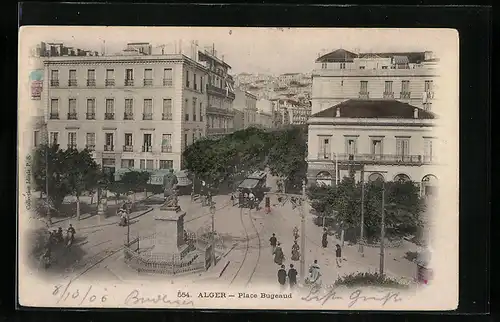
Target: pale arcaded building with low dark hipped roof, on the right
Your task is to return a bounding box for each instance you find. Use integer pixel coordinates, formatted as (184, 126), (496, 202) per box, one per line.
(307, 99), (442, 195)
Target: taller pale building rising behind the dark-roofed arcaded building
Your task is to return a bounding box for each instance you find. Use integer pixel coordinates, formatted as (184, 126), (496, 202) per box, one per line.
(312, 49), (438, 114)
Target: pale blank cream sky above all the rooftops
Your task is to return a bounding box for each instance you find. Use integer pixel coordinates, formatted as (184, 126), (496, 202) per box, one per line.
(20, 26), (458, 74)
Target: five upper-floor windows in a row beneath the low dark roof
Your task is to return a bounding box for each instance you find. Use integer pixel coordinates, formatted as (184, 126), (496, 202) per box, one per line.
(319, 136), (434, 158)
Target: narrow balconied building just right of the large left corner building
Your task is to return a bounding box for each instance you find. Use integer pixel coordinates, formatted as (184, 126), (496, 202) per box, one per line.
(198, 47), (235, 136)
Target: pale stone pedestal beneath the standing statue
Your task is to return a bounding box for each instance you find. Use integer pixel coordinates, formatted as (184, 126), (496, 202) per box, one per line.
(151, 207), (188, 258)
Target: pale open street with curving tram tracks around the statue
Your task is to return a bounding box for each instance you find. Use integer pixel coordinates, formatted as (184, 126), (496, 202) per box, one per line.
(47, 186), (415, 287)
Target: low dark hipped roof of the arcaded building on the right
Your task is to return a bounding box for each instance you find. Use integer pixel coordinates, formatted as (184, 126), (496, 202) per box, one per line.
(311, 99), (435, 119)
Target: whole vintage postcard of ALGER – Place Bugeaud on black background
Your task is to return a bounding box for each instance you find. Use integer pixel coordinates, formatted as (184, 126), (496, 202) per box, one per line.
(17, 26), (459, 311)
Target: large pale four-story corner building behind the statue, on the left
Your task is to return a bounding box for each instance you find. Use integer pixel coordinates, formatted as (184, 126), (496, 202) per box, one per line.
(42, 51), (207, 172)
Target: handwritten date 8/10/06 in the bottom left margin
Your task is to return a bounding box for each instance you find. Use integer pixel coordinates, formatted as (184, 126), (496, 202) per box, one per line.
(52, 282), (108, 305)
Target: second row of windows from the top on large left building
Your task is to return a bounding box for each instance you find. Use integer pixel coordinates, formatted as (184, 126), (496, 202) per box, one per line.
(49, 97), (203, 122)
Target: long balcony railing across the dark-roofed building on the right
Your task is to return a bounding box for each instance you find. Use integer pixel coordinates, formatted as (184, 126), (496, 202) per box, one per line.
(316, 152), (436, 164)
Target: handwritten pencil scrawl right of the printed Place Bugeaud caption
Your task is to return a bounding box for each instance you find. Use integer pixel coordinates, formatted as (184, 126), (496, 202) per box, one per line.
(301, 288), (403, 308)
